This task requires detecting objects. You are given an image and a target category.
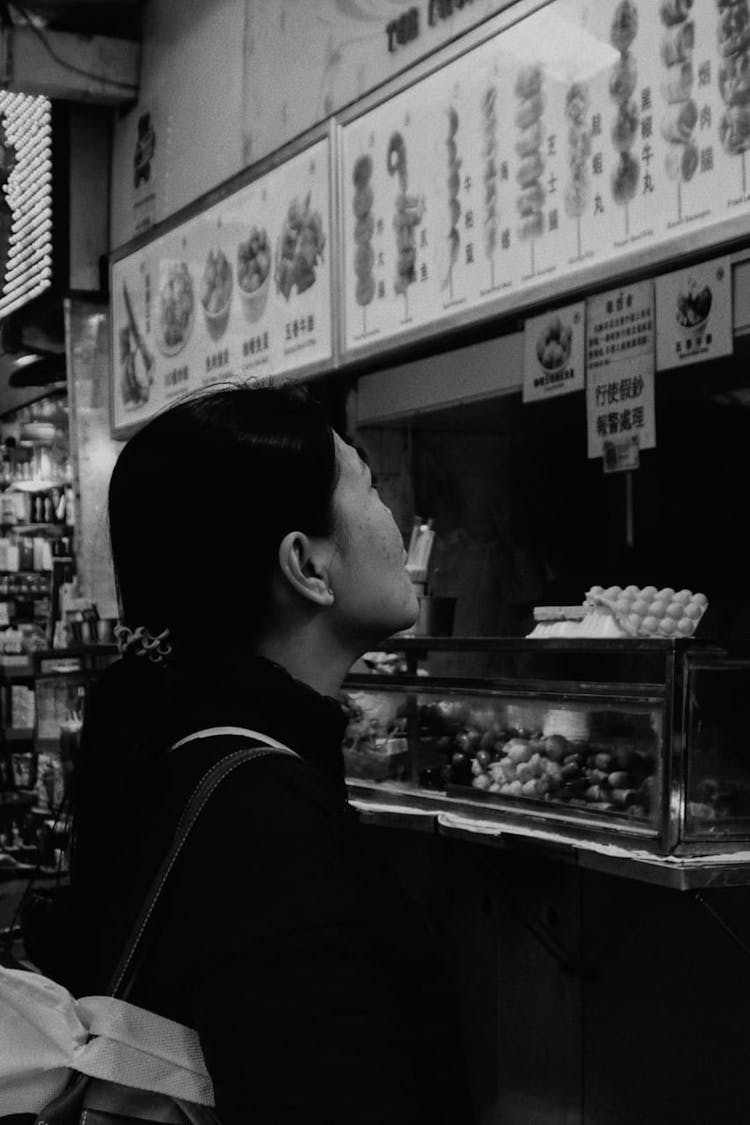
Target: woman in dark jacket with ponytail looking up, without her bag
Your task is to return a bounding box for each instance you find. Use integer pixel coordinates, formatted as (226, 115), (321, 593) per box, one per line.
(71, 387), (479, 1125)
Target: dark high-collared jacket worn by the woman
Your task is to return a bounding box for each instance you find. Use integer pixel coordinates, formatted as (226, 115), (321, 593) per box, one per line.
(70, 659), (472, 1125)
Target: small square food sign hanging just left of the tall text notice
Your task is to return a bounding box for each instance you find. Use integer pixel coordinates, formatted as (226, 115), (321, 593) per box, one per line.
(523, 300), (586, 403)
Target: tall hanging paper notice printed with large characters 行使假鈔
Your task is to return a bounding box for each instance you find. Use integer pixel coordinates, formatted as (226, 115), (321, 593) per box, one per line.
(586, 281), (657, 458)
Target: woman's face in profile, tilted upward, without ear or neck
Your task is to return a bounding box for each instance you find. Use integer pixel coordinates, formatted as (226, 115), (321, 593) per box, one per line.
(331, 434), (419, 642)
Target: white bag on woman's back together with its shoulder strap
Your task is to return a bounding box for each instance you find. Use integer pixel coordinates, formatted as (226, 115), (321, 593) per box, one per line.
(0, 727), (299, 1125)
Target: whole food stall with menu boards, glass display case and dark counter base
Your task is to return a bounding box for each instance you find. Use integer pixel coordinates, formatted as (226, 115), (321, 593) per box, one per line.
(102, 0), (750, 1123)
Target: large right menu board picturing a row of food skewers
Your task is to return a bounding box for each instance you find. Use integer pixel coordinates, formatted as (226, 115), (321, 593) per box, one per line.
(341, 0), (750, 353)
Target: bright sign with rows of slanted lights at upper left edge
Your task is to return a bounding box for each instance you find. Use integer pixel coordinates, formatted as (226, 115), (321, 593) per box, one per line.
(0, 90), (52, 318)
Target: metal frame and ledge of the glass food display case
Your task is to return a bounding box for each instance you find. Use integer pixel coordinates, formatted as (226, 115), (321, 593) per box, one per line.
(344, 637), (750, 888)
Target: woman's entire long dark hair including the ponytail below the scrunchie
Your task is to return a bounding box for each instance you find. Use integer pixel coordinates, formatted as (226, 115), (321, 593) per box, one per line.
(71, 385), (337, 967)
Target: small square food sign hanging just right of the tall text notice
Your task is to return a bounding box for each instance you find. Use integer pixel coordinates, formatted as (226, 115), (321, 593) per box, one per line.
(657, 258), (732, 371)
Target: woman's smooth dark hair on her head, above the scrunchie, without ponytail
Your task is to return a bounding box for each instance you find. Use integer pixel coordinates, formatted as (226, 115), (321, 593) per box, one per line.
(109, 386), (336, 655)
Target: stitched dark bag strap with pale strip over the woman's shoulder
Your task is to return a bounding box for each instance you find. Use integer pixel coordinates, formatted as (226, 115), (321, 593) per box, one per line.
(109, 727), (299, 996)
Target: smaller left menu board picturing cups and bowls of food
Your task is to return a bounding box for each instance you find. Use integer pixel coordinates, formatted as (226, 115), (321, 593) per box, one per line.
(111, 138), (332, 433)
